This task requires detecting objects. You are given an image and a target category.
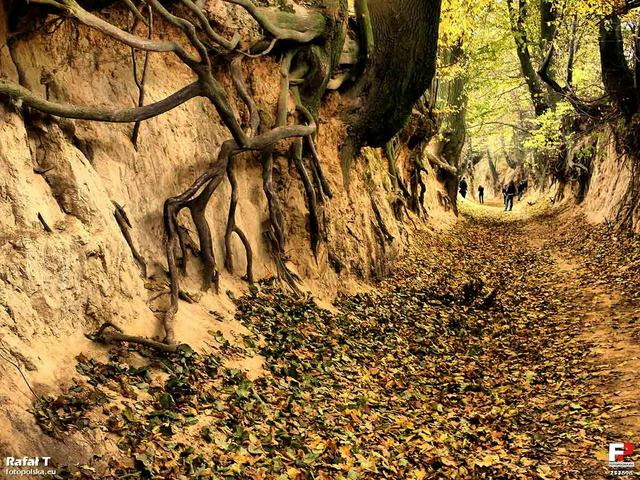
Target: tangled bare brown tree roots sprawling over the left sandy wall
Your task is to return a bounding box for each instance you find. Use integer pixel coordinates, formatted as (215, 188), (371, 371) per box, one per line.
(0, 0), (331, 352)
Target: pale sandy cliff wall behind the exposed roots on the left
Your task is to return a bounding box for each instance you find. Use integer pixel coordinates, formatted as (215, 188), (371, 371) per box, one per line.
(0, 1), (456, 463)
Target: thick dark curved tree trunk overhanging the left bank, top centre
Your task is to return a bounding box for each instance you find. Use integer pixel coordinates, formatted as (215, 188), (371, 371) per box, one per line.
(347, 0), (441, 147)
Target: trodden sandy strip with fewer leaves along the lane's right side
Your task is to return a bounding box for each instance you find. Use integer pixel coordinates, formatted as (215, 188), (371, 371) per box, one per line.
(525, 204), (640, 443)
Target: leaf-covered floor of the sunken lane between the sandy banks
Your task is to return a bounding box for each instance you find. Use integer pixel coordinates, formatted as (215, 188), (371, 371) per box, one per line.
(35, 196), (640, 480)
